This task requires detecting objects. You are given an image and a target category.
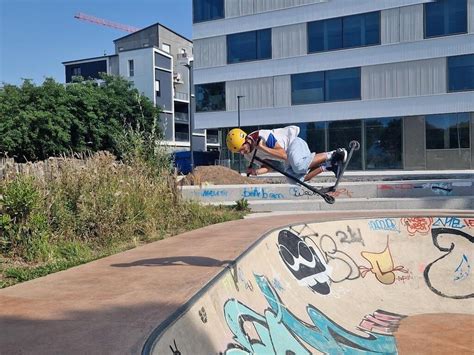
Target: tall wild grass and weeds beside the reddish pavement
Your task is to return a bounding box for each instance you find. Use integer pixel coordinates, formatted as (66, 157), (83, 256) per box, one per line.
(0, 138), (242, 287)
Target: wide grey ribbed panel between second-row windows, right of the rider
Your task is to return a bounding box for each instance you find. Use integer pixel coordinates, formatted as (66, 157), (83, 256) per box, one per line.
(361, 58), (447, 100)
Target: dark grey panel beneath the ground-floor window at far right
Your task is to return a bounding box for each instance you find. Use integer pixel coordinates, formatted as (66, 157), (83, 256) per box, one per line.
(426, 149), (471, 170)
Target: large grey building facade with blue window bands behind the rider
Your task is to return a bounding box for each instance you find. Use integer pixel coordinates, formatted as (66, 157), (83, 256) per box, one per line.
(193, 0), (474, 170)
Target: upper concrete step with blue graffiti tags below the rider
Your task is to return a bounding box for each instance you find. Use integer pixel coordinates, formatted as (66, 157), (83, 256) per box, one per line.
(182, 179), (474, 203)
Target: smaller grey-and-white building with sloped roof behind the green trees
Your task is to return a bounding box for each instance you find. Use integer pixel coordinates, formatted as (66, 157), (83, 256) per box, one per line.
(63, 23), (219, 151)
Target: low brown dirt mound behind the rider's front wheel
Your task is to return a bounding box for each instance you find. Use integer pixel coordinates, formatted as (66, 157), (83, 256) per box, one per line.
(180, 165), (266, 185)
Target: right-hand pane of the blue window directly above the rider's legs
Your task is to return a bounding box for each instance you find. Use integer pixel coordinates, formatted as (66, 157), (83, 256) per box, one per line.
(325, 68), (360, 101)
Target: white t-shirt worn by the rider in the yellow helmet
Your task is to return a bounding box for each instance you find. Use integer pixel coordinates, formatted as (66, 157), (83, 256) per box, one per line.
(244, 126), (300, 164)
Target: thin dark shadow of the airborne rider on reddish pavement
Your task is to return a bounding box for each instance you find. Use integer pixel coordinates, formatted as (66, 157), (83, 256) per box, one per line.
(110, 256), (233, 267)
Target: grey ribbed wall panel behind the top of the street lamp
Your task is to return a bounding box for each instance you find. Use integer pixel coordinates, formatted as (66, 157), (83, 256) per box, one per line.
(226, 78), (273, 111)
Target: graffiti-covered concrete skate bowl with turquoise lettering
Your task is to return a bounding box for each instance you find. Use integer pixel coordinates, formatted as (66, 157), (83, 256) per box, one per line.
(142, 214), (474, 355)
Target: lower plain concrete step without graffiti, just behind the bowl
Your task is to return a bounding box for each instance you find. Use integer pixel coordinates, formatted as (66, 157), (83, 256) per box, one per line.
(209, 196), (474, 212)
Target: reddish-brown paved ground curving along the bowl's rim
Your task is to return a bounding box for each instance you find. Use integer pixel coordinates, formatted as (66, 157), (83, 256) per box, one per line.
(0, 211), (472, 354)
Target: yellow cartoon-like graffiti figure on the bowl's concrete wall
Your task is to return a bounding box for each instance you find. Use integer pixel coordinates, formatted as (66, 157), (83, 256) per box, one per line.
(360, 237), (408, 285)
